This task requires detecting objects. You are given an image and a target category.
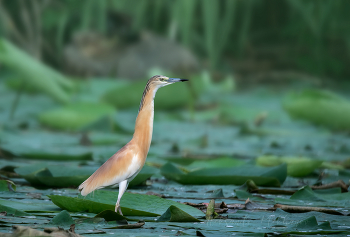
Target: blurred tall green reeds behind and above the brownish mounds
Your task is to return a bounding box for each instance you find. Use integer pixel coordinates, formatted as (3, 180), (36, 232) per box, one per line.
(0, 0), (350, 79)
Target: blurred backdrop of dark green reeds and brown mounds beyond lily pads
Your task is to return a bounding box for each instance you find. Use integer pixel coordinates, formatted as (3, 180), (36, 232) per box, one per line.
(0, 0), (350, 80)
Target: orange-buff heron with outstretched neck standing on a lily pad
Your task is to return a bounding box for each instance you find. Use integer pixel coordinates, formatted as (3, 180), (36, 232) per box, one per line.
(78, 75), (188, 215)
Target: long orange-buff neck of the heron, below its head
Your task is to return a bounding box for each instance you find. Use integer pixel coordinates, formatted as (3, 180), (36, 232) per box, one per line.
(133, 83), (157, 159)
